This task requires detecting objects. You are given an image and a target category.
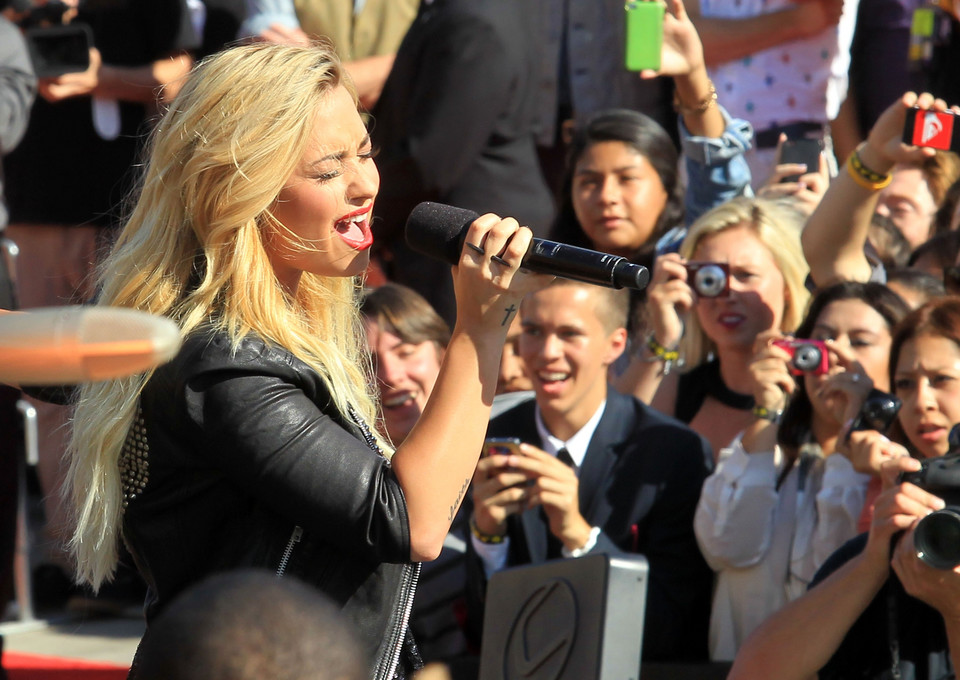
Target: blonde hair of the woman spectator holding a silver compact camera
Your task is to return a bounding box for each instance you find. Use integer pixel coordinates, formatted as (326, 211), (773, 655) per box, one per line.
(680, 197), (810, 371)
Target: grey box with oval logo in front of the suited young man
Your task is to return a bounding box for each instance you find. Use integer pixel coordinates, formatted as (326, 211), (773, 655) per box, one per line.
(480, 555), (649, 680)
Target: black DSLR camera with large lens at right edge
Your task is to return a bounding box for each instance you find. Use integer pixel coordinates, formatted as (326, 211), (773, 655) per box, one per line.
(900, 424), (960, 569)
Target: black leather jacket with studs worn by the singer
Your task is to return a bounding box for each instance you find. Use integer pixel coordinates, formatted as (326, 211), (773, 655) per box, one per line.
(120, 331), (419, 679)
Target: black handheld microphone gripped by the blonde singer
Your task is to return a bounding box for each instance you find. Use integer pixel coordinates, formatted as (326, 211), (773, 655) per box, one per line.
(406, 202), (650, 290)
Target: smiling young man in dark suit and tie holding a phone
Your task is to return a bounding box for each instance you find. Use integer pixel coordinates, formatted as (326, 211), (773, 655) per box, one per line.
(471, 280), (713, 662)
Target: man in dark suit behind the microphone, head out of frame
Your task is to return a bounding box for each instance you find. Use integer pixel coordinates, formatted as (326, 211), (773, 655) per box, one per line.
(370, 0), (553, 325)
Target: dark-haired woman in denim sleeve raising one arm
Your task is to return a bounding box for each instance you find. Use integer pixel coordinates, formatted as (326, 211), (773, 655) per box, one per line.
(552, 0), (752, 274)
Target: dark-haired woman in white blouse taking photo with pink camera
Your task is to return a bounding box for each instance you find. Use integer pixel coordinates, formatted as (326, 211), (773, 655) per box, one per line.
(694, 283), (908, 661)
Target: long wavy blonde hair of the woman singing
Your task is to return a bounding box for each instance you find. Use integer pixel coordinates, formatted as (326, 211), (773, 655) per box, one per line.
(64, 44), (386, 587)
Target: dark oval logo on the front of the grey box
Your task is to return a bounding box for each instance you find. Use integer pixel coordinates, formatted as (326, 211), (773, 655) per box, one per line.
(503, 579), (578, 680)
